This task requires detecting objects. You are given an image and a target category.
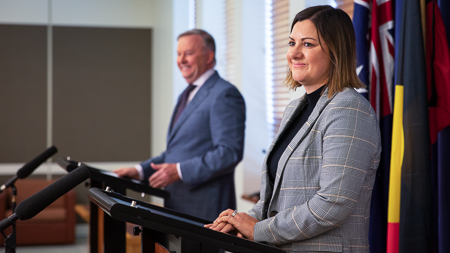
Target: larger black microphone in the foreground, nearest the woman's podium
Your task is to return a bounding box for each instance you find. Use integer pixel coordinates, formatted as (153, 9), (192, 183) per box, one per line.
(0, 165), (90, 231)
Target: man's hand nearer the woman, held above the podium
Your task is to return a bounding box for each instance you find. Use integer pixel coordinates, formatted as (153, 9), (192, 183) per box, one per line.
(148, 163), (180, 188)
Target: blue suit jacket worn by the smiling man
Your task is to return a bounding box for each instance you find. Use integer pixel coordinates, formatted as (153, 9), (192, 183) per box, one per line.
(141, 72), (245, 221)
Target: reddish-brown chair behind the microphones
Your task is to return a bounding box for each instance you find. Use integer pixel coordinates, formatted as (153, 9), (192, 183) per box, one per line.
(0, 179), (76, 245)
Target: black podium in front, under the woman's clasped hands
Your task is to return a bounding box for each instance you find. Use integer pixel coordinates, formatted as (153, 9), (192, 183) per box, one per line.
(88, 188), (285, 253)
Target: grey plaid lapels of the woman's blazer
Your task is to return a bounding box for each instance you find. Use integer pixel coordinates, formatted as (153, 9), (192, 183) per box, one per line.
(270, 88), (335, 206)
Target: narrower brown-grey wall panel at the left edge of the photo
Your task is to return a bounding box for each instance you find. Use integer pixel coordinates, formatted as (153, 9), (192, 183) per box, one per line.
(0, 25), (47, 163)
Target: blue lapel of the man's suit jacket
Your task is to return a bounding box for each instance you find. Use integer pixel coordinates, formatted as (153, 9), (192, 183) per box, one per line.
(167, 71), (219, 143)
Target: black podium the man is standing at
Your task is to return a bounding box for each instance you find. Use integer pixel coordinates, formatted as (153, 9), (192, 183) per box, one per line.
(56, 158), (170, 253)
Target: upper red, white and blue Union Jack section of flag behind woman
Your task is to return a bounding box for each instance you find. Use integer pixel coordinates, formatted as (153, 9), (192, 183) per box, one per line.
(353, 0), (394, 116)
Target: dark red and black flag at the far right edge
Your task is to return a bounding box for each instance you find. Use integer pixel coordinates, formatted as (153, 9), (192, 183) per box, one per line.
(426, 0), (450, 252)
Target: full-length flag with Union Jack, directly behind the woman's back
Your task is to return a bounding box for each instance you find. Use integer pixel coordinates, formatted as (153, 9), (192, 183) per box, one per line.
(353, 0), (395, 253)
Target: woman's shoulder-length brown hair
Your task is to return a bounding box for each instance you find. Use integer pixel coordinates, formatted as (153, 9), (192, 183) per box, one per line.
(285, 5), (365, 97)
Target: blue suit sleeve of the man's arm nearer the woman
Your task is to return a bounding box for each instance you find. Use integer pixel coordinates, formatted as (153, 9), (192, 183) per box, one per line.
(180, 86), (245, 187)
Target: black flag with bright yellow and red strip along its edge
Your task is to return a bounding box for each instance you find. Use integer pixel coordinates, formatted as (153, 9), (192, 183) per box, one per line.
(387, 0), (433, 253)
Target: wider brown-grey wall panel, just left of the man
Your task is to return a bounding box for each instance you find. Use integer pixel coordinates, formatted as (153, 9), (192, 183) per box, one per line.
(53, 27), (151, 161)
